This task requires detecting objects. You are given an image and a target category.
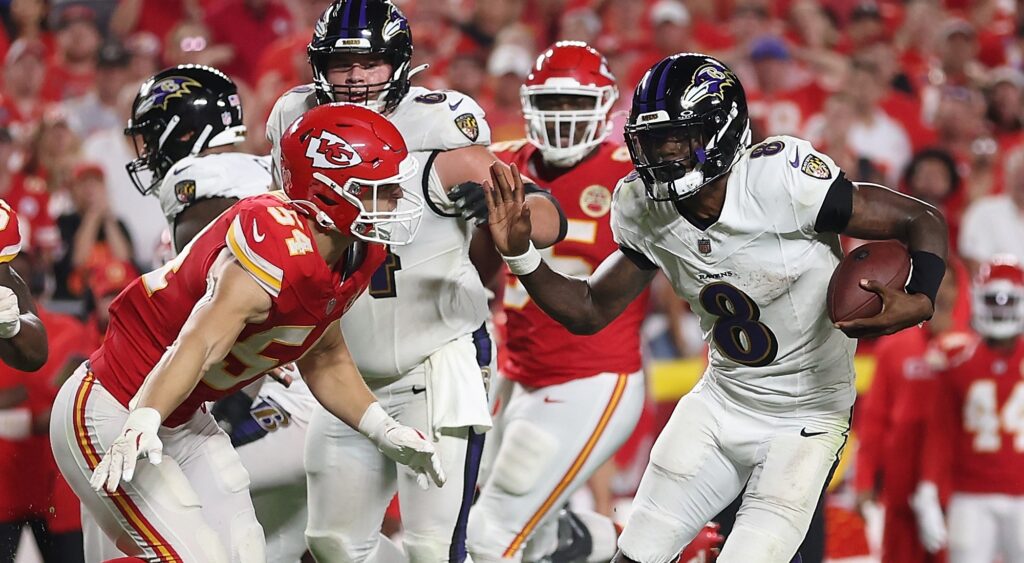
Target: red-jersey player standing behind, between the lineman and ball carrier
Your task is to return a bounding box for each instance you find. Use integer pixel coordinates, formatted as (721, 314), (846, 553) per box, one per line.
(468, 41), (649, 561)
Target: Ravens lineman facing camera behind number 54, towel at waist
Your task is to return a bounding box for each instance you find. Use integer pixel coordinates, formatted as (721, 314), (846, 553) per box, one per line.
(267, 0), (565, 563)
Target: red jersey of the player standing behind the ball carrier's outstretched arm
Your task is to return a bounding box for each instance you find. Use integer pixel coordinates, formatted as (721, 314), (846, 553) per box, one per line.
(492, 140), (649, 387)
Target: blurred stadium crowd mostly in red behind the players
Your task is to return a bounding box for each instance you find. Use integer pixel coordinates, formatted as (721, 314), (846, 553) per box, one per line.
(0, 0), (1024, 561)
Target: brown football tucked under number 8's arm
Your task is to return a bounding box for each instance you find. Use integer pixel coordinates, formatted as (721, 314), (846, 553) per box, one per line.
(825, 241), (910, 322)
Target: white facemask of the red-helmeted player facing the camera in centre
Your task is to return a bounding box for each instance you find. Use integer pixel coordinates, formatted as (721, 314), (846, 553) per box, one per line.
(519, 79), (618, 167)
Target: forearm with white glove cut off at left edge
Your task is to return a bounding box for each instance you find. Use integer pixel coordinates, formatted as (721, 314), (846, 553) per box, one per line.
(0, 264), (48, 372)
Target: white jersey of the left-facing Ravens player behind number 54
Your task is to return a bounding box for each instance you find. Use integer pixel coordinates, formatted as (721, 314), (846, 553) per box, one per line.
(157, 153), (315, 421)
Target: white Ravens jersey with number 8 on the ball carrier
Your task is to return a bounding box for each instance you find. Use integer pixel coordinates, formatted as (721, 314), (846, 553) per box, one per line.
(611, 136), (856, 416)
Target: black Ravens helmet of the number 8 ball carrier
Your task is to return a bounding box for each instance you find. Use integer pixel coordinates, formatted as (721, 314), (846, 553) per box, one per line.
(626, 53), (751, 202)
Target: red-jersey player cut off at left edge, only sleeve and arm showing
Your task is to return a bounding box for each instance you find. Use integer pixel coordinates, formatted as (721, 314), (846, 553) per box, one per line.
(0, 200), (47, 372)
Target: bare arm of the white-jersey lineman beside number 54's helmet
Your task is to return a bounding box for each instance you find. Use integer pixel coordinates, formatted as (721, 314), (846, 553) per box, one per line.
(434, 144), (566, 249)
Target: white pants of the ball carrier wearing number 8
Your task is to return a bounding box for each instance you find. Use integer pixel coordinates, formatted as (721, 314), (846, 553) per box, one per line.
(618, 379), (850, 563)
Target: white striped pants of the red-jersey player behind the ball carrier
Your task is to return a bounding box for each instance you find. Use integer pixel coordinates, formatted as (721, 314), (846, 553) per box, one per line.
(469, 372), (644, 563)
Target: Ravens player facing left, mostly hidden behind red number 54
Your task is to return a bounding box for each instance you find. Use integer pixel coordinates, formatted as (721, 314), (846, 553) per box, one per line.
(86, 64), (316, 563)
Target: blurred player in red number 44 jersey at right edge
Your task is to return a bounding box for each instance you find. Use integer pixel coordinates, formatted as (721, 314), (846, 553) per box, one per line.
(911, 257), (1024, 563)
